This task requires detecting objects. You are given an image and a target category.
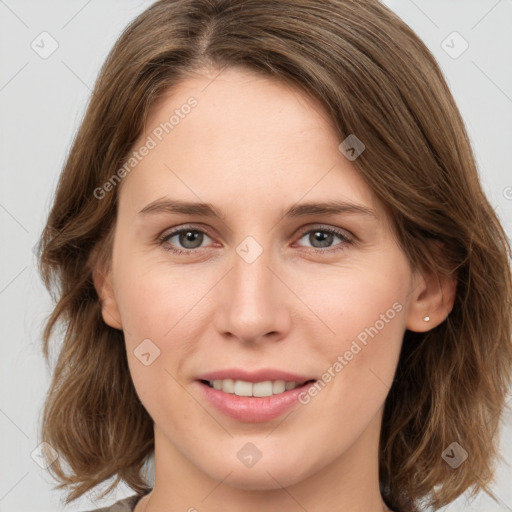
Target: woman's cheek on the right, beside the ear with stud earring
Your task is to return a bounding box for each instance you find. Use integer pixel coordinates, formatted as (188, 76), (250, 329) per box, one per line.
(308, 264), (407, 386)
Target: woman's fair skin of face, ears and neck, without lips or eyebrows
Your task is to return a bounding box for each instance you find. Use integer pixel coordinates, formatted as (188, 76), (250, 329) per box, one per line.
(94, 68), (455, 512)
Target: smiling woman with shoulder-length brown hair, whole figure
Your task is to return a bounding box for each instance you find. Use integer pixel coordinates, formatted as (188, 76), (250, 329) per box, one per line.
(40, 0), (512, 512)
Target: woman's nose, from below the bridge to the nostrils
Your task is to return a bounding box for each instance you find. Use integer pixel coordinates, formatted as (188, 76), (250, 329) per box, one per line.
(214, 242), (292, 344)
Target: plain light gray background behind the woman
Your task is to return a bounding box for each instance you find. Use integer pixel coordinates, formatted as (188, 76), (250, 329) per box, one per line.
(0, 0), (512, 512)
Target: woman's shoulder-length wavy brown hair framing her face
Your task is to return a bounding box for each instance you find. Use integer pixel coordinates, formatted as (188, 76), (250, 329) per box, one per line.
(39, 0), (512, 510)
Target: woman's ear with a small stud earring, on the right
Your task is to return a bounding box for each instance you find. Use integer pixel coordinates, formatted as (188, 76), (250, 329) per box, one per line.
(406, 244), (457, 332)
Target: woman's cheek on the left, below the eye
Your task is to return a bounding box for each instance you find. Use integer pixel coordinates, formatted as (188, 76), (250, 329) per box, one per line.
(115, 251), (218, 402)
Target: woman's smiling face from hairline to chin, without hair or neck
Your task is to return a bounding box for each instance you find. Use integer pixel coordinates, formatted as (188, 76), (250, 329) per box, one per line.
(98, 69), (428, 489)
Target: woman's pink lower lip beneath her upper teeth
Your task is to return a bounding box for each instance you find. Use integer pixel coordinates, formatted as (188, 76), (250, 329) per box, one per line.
(196, 381), (316, 423)
